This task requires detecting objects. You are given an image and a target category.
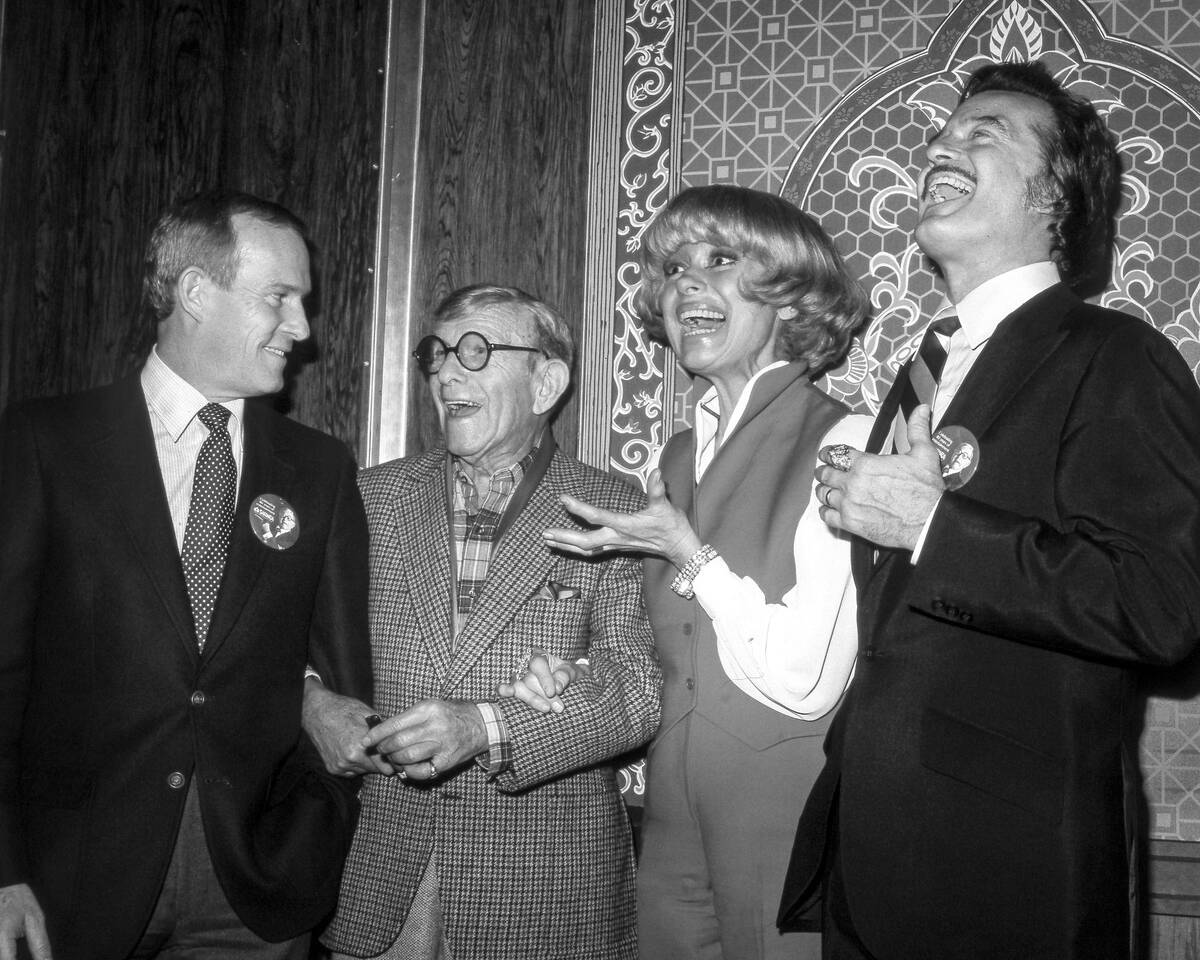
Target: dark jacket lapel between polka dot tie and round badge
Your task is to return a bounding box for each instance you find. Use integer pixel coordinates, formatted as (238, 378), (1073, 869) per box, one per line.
(204, 400), (288, 658)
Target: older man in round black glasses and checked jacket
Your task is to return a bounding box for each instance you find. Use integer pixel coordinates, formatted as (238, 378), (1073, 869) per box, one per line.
(323, 286), (660, 960)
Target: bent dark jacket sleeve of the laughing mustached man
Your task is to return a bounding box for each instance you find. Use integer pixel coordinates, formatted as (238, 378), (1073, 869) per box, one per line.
(906, 324), (1200, 665)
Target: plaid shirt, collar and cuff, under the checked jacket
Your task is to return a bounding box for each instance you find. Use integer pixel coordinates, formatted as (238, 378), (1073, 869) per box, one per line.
(454, 448), (538, 776)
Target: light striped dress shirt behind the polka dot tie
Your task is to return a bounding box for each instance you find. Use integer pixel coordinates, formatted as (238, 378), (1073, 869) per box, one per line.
(142, 347), (246, 551)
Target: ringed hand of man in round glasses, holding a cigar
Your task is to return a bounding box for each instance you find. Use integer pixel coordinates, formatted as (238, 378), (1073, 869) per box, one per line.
(360, 700), (487, 780)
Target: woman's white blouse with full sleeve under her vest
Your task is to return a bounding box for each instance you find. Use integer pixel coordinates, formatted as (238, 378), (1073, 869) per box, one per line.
(655, 361), (871, 720)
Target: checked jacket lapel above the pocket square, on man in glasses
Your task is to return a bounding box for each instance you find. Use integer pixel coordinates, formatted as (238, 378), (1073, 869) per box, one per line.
(442, 454), (566, 696)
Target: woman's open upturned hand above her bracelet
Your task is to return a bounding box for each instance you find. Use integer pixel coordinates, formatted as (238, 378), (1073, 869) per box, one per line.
(541, 470), (702, 568)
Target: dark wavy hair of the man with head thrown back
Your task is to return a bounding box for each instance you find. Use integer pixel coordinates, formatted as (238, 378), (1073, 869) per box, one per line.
(959, 61), (1121, 296)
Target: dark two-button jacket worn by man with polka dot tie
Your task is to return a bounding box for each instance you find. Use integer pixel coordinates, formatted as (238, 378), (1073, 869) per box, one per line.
(0, 378), (370, 960)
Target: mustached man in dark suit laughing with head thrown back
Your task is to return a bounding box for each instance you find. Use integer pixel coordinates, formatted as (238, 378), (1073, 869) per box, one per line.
(781, 64), (1200, 960)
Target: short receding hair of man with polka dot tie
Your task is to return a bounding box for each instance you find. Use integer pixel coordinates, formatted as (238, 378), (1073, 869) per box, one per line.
(143, 191), (307, 320)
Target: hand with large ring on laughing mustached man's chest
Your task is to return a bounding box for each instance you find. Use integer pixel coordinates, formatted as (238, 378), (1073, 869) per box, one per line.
(816, 403), (946, 550)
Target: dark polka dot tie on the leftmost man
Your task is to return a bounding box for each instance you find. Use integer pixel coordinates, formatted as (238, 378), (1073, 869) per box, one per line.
(181, 403), (238, 650)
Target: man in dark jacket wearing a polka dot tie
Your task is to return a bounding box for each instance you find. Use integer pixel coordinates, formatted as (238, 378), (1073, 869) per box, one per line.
(0, 194), (371, 960)
